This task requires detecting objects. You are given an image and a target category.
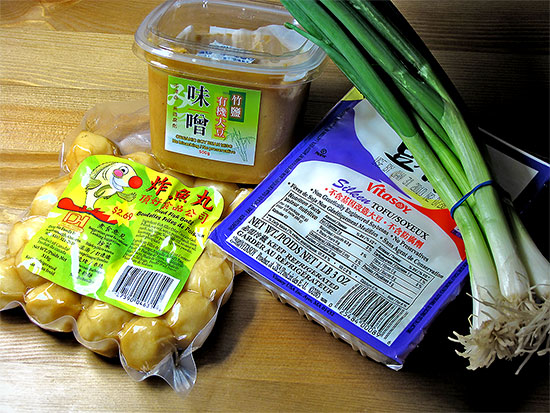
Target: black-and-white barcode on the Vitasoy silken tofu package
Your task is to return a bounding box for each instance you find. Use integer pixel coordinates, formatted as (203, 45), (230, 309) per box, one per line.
(335, 285), (406, 338)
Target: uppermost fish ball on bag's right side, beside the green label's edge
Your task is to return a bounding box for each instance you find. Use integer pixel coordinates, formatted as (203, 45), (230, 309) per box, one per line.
(185, 252), (233, 301)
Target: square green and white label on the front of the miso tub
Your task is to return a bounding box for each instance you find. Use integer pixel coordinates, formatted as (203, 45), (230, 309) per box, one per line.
(164, 76), (261, 165)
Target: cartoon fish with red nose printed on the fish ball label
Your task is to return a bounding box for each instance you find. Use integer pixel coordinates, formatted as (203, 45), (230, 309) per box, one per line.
(84, 162), (143, 209)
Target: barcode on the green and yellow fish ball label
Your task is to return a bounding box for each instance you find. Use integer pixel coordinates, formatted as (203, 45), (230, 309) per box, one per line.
(105, 264), (179, 314)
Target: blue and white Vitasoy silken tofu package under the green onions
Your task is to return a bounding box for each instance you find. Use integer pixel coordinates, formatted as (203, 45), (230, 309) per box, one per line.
(210, 90), (549, 370)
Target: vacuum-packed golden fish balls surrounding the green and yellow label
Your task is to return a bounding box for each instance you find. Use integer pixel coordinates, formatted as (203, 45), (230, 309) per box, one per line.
(0, 132), (244, 372)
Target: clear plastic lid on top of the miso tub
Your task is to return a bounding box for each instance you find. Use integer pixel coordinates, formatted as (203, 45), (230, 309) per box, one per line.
(134, 0), (326, 82)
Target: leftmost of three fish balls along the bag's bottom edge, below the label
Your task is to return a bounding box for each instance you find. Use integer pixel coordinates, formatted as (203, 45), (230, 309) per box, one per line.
(25, 282), (82, 332)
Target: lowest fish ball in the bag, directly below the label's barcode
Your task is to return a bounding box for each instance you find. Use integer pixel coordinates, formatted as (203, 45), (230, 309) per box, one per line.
(119, 317), (176, 372)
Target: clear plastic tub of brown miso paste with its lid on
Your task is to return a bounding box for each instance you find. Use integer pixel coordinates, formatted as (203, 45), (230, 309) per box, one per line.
(134, 0), (325, 184)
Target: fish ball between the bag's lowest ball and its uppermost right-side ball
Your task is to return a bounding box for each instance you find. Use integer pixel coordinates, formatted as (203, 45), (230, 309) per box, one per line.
(164, 291), (216, 348)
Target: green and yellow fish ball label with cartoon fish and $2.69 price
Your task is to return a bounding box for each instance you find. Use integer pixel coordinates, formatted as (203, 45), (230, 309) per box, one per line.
(22, 155), (223, 317)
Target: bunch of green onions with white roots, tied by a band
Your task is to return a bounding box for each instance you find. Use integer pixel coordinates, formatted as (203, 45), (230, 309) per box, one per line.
(281, 0), (550, 371)
